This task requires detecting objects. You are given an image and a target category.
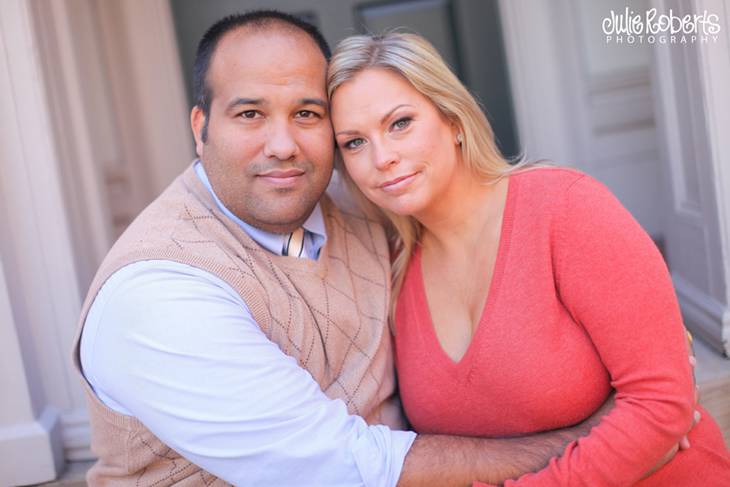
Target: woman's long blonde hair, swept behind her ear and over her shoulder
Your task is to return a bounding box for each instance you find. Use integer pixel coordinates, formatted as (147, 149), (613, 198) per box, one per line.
(327, 32), (524, 324)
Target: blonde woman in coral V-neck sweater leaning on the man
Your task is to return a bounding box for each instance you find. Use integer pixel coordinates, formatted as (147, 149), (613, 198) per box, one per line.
(328, 34), (730, 486)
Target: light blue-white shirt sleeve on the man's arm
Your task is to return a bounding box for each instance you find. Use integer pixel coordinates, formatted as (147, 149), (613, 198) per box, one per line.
(81, 261), (415, 486)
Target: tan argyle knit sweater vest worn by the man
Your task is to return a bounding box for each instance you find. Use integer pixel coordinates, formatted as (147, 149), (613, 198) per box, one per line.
(69, 167), (404, 487)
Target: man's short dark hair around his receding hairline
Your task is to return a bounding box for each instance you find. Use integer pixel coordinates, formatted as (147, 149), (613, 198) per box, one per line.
(193, 10), (332, 142)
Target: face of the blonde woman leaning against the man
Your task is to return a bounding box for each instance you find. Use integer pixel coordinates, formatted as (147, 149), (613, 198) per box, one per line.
(331, 68), (460, 215)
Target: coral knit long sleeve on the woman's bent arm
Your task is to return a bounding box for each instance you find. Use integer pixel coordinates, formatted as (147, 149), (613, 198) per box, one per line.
(505, 176), (693, 486)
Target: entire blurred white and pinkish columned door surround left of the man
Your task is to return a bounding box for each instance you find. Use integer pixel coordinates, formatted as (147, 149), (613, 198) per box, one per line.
(0, 0), (193, 472)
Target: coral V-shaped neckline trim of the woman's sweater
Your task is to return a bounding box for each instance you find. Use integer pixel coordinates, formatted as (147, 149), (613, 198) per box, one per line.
(413, 175), (518, 372)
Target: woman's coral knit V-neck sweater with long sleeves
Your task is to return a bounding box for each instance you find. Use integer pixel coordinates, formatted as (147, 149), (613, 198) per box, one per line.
(395, 168), (730, 486)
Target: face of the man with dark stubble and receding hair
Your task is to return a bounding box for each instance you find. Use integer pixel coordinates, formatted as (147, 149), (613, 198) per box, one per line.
(191, 27), (333, 233)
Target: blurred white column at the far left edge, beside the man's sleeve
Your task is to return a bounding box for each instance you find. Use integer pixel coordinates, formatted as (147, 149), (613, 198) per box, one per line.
(0, 0), (108, 485)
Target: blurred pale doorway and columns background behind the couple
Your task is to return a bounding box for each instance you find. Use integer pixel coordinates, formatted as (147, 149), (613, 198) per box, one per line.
(0, 0), (730, 485)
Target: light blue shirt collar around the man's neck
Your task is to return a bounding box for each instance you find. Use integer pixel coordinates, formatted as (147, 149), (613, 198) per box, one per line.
(193, 159), (327, 259)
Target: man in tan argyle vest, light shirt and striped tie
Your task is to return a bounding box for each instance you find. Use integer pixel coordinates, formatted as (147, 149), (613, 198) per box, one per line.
(74, 11), (656, 486)
